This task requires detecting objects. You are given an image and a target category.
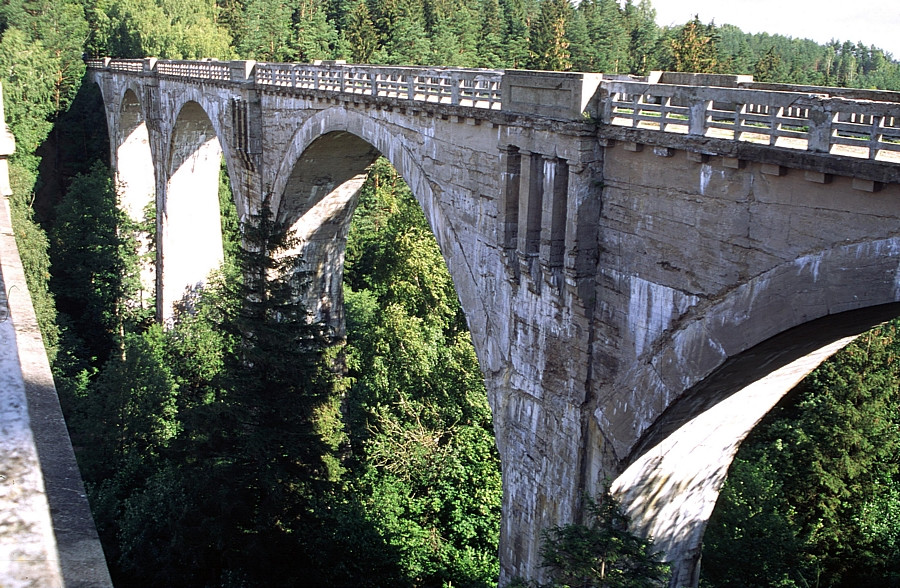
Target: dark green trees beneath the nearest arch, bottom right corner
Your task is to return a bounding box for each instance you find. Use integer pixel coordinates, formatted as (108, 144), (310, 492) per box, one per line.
(703, 321), (900, 586)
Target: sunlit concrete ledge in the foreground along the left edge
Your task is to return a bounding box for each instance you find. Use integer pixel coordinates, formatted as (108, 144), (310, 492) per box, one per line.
(0, 197), (112, 588)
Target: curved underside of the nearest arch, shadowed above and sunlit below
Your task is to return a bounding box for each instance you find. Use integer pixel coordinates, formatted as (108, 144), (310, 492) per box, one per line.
(612, 302), (900, 586)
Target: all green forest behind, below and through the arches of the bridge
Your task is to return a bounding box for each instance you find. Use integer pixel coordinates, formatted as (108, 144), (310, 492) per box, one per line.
(0, 0), (900, 588)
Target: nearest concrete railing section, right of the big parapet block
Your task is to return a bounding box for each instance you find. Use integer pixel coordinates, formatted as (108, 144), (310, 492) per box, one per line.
(602, 81), (900, 159)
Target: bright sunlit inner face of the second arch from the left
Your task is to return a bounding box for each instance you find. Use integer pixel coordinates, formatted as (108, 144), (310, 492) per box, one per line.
(157, 101), (224, 320)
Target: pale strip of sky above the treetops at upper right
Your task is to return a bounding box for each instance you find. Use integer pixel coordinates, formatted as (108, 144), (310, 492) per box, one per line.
(652, 0), (900, 59)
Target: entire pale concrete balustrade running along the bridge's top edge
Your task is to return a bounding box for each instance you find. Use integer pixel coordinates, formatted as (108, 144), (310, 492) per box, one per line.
(87, 58), (900, 161)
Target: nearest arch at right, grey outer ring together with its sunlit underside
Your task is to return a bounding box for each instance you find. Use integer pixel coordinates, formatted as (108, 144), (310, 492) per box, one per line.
(613, 237), (900, 586)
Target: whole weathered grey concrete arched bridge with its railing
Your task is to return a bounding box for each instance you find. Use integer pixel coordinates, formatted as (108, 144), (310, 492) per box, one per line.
(89, 59), (900, 586)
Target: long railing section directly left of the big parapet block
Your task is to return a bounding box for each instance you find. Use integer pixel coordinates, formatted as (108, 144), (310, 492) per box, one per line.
(256, 63), (503, 110)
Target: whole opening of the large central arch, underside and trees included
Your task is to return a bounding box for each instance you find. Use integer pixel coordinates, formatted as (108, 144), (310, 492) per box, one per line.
(279, 132), (502, 585)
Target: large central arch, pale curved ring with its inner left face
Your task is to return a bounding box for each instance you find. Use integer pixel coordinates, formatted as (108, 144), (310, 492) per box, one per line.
(272, 106), (496, 369)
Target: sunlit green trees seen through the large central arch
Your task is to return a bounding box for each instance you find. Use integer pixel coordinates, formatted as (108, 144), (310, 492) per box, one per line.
(345, 160), (501, 585)
